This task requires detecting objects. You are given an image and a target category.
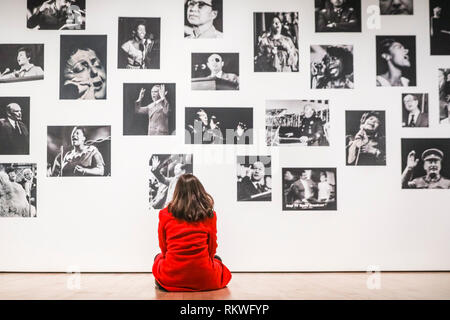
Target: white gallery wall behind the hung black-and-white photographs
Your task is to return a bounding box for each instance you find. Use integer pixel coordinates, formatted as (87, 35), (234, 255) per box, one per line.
(0, 0), (450, 272)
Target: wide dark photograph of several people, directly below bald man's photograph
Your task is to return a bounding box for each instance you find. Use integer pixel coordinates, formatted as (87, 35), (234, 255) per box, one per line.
(185, 107), (253, 144)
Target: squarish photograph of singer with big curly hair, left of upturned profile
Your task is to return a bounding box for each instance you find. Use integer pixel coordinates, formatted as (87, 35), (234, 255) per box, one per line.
(311, 45), (354, 89)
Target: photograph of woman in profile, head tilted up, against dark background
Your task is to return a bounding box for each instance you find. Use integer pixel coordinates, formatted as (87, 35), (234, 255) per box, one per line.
(376, 36), (416, 87)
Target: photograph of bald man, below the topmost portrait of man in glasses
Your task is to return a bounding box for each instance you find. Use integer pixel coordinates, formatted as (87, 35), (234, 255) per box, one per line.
(191, 52), (239, 90)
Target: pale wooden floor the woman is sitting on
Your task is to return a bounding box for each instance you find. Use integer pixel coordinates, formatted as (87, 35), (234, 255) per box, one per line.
(0, 272), (450, 300)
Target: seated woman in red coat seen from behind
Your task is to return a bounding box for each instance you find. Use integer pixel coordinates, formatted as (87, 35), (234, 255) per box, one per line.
(152, 174), (231, 291)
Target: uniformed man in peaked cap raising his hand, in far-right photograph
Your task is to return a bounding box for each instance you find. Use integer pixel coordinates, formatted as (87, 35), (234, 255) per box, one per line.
(402, 148), (450, 189)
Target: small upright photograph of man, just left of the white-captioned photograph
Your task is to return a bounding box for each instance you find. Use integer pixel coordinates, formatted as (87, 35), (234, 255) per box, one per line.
(236, 156), (272, 201)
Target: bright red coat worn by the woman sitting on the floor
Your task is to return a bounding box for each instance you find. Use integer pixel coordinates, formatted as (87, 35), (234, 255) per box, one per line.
(152, 208), (231, 291)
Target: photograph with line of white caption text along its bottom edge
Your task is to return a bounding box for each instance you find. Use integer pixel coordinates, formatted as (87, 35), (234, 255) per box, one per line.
(282, 168), (337, 211)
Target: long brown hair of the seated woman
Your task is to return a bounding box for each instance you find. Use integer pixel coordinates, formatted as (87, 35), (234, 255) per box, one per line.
(168, 173), (214, 222)
